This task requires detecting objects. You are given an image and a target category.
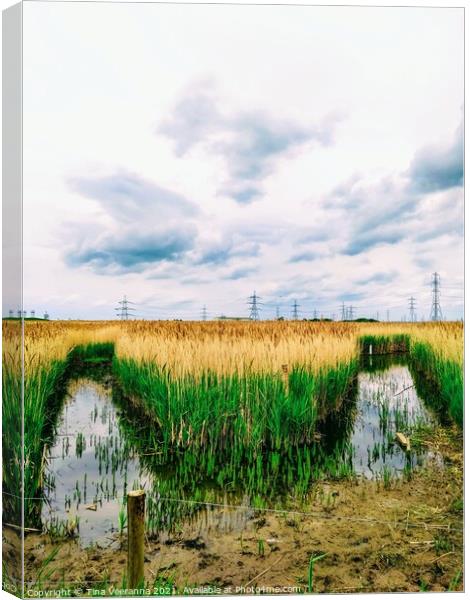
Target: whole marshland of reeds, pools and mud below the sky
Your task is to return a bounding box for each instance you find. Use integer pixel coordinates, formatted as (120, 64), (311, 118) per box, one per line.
(3, 321), (463, 593)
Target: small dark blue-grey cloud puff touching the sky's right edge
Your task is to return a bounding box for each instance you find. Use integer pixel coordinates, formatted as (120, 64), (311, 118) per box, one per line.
(408, 125), (463, 193)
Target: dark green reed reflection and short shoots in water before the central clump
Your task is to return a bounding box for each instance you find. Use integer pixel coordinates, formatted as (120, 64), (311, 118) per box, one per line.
(113, 389), (360, 535)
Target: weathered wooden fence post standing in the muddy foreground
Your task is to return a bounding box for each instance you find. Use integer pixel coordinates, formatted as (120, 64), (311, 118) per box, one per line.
(127, 490), (145, 589)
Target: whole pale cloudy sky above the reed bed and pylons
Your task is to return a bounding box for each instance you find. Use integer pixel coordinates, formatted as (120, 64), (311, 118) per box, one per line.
(24, 3), (464, 319)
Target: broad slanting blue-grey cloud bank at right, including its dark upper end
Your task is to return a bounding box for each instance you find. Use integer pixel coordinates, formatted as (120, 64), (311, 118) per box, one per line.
(323, 122), (463, 256)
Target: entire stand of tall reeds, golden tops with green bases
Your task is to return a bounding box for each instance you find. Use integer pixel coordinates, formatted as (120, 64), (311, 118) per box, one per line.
(3, 321), (463, 524)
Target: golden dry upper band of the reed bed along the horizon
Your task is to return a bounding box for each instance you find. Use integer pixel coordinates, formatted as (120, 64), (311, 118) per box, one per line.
(3, 321), (463, 375)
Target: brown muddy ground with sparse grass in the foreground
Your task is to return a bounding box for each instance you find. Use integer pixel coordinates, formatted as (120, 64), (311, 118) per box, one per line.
(5, 428), (463, 595)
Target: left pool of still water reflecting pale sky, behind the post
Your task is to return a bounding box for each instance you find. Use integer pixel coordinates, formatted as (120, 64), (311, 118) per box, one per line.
(42, 379), (146, 544)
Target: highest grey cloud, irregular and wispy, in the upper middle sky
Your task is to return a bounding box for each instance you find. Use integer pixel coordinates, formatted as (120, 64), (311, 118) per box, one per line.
(157, 83), (339, 204)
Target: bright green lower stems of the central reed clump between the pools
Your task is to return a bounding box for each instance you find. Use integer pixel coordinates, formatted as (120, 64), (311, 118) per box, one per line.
(113, 358), (356, 455)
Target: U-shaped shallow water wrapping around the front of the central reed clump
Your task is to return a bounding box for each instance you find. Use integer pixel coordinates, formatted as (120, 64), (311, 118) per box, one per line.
(42, 359), (438, 545)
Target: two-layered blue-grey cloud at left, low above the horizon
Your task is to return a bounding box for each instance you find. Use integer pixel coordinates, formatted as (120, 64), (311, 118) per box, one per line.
(65, 171), (198, 276)
